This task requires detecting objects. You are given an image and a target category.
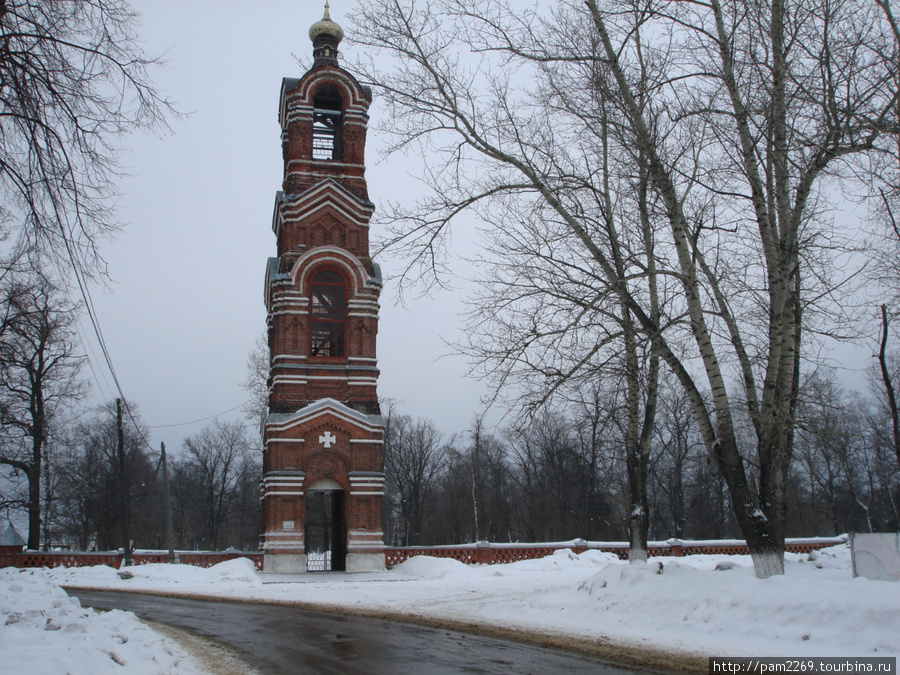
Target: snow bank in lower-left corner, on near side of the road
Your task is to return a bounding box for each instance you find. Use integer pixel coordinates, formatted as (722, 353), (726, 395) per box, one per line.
(0, 568), (201, 675)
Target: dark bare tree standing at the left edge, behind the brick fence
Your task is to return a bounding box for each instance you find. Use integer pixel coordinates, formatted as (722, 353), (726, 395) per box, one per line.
(0, 277), (87, 549)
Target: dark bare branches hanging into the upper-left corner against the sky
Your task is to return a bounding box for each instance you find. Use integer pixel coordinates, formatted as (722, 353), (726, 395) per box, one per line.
(0, 0), (172, 273)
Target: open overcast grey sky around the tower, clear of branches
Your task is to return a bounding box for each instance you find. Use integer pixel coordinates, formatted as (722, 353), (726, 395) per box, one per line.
(83, 0), (483, 448)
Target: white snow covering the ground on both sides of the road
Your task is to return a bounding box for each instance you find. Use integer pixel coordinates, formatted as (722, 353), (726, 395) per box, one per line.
(0, 545), (900, 673)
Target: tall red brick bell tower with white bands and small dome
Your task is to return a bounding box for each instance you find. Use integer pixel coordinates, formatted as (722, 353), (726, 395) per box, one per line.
(262, 3), (384, 572)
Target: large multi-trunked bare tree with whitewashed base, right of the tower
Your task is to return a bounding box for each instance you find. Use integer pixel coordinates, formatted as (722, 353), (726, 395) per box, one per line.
(354, 0), (896, 577)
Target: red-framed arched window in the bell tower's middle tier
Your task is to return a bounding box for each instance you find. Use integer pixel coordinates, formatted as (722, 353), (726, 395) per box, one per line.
(309, 270), (347, 357)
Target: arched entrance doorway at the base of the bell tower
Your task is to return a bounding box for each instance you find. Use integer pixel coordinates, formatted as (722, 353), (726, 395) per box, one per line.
(305, 478), (347, 572)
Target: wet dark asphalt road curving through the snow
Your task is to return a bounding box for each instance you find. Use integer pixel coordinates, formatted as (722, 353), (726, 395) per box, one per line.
(74, 589), (643, 675)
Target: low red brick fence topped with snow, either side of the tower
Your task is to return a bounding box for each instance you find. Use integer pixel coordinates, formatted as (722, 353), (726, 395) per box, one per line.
(0, 536), (847, 570)
